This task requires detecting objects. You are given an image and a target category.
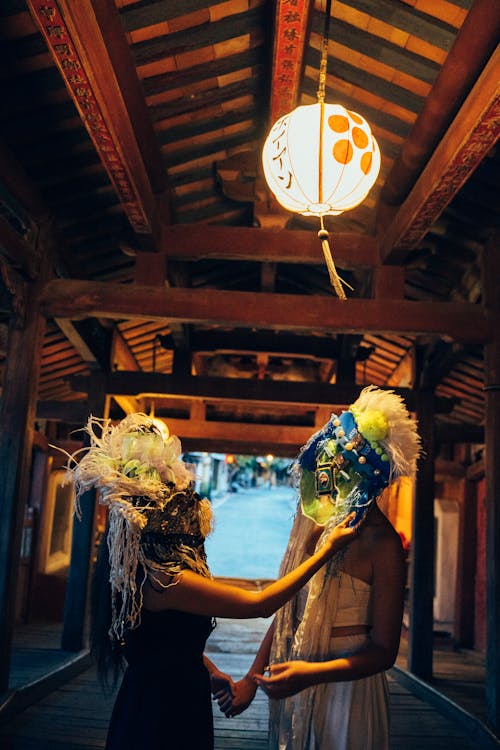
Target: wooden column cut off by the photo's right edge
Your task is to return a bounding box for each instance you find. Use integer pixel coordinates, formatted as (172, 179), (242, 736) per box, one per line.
(483, 232), (500, 732)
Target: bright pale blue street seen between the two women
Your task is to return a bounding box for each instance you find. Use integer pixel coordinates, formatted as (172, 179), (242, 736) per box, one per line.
(206, 486), (297, 578)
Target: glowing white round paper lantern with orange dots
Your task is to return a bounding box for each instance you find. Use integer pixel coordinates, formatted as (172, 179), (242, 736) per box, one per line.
(262, 103), (380, 216)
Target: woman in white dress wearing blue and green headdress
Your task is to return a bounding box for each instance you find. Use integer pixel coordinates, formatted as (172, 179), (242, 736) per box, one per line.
(217, 386), (420, 750)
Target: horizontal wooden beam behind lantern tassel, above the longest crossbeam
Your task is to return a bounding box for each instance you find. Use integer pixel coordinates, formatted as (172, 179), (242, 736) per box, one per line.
(161, 224), (379, 269)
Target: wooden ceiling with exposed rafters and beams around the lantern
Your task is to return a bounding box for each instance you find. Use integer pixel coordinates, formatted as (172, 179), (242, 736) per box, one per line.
(0, 0), (500, 453)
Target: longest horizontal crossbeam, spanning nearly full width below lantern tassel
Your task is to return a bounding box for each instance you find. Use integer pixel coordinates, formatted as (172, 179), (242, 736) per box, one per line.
(41, 279), (494, 342)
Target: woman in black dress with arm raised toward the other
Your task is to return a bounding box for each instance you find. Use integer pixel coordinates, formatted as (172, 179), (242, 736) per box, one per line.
(70, 414), (357, 750)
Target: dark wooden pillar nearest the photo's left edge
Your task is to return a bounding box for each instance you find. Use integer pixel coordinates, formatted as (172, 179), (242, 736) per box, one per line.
(0, 268), (45, 693)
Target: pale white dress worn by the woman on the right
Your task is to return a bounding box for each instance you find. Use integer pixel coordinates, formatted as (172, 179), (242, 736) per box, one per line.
(270, 571), (389, 750)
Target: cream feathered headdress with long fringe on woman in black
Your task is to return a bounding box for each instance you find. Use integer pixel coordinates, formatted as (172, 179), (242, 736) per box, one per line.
(63, 413), (212, 640)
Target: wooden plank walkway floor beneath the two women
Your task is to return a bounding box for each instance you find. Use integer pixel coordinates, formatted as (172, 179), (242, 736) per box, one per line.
(0, 620), (500, 750)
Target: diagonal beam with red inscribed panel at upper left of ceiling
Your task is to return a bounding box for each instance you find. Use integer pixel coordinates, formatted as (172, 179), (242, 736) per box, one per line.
(28, 0), (165, 237)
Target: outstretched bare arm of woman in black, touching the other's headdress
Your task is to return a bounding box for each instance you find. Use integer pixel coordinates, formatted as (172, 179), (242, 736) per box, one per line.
(144, 514), (357, 618)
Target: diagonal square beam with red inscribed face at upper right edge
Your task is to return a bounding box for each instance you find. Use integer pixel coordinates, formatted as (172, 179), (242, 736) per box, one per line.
(380, 43), (500, 264)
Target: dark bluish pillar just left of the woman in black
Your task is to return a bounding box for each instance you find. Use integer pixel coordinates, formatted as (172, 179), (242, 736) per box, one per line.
(61, 374), (106, 651)
